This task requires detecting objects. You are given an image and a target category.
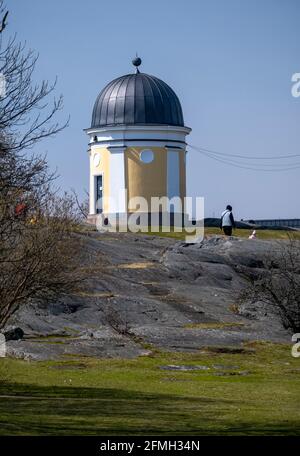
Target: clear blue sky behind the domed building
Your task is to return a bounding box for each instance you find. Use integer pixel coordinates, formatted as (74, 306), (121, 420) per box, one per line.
(6, 0), (300, 219)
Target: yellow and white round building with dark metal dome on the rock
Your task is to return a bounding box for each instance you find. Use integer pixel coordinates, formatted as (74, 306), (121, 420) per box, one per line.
(85, 58), (191, 225)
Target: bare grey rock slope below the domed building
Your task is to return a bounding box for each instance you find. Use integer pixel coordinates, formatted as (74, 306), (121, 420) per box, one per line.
(7, 232), (291, 359)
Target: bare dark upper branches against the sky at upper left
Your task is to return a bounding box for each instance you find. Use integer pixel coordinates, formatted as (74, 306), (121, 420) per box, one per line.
(0, 2), (68, 151)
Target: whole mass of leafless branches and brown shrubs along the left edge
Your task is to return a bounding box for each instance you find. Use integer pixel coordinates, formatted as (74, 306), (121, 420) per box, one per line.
(0, 2), (88, 329)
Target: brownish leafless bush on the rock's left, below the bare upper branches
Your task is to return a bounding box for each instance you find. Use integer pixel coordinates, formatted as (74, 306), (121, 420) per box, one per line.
(0, 194), (83, 327)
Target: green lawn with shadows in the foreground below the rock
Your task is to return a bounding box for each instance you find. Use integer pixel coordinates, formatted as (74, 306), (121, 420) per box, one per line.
(0, 343), (300, 435)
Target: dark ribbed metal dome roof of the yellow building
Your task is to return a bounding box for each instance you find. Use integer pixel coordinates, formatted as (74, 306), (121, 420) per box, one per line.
(91, 71), (184, 128)
